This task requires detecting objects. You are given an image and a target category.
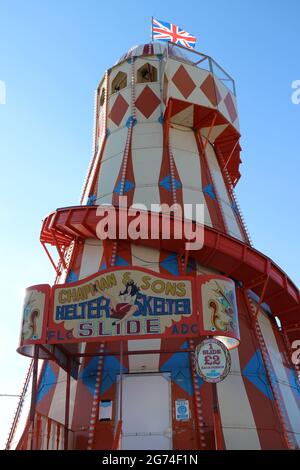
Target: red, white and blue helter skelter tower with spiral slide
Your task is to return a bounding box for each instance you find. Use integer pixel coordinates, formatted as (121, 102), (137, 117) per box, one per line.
(14, 43), (300, 450)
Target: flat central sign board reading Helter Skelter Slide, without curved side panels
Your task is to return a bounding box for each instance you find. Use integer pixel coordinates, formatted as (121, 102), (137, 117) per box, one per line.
(47, 268), (199, 343)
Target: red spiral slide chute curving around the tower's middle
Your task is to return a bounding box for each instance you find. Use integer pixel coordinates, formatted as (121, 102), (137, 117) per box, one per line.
(41, 206), (300, 326)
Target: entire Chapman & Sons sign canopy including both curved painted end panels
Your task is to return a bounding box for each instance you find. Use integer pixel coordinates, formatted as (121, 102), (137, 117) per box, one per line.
(18, 267), (240, 357)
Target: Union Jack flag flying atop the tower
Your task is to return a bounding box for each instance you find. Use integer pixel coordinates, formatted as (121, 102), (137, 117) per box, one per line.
(152, 18), (197, 49)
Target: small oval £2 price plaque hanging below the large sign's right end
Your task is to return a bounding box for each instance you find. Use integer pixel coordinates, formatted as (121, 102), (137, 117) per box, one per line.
(195, 338), (231, 383)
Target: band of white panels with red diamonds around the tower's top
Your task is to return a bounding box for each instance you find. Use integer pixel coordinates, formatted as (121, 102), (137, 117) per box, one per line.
(108, 58), (239, 131)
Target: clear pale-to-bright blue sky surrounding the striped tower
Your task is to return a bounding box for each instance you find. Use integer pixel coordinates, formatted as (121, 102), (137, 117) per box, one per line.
(0, 0), (300, 447)
